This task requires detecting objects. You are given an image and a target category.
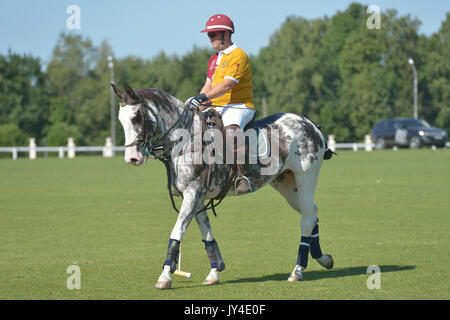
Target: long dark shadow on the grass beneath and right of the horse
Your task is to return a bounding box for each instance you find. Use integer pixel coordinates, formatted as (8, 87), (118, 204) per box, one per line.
(223, 265), (416, 284)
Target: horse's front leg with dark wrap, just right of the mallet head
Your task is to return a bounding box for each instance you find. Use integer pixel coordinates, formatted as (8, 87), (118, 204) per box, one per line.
(195, 211), (225, 285)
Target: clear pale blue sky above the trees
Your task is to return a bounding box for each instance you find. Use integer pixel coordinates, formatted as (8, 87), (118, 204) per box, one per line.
(0, 0), (450, 63)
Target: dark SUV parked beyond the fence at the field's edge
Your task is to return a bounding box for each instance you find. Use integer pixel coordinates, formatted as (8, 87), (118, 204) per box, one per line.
(372, 118), (448, 149)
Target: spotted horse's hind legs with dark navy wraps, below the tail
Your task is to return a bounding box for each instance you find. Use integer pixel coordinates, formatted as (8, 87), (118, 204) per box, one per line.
(272, 169), (332, 281)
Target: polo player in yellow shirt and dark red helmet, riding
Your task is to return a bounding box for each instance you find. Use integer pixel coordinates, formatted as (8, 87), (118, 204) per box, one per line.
(186, 14), (255, 195)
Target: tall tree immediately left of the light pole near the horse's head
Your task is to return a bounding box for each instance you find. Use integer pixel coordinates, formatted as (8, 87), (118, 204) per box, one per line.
(47, 33), (112, 145)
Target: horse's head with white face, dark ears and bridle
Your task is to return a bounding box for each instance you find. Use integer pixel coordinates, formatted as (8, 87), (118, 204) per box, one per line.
(111, 83), (158, 166)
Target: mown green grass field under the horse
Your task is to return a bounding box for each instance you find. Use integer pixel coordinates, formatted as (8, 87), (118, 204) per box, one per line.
(0, 149), (450, 300)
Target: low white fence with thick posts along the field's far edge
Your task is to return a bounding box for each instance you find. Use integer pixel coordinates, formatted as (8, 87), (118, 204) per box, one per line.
(0, 135), (450, 160)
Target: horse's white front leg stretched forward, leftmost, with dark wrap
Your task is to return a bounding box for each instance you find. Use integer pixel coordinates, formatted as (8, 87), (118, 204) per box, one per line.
(155, 189), (203, 289)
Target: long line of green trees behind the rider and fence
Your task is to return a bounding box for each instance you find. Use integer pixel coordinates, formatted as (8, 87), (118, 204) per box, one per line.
(0, 3), (450, 146)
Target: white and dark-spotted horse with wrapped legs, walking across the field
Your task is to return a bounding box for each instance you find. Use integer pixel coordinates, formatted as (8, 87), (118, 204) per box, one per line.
(111, 84), (334, 289)
